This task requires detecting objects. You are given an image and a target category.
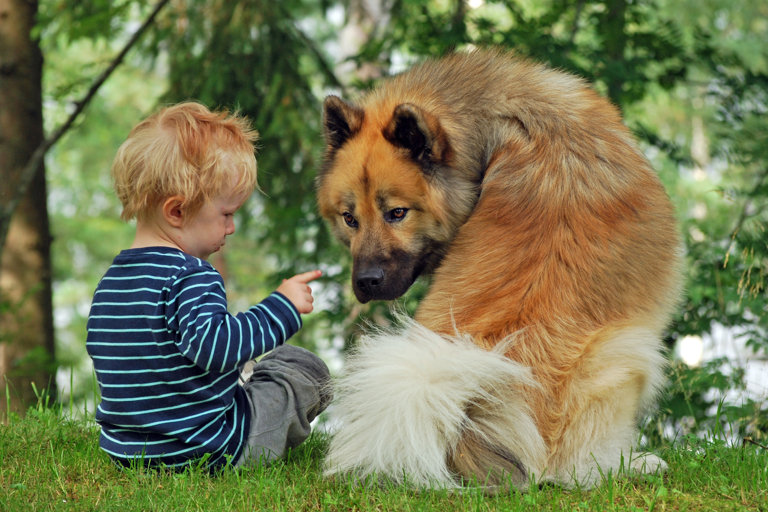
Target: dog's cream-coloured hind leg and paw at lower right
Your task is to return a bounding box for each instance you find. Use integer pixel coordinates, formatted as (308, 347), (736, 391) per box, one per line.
(548, 327), (666, 487)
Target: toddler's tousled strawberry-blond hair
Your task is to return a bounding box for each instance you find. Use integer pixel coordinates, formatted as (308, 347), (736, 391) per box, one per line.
(112, 102), (258, 220)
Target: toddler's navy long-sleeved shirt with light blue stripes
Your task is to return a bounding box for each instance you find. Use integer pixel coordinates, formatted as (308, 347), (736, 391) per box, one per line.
(86, 247), (301, 467)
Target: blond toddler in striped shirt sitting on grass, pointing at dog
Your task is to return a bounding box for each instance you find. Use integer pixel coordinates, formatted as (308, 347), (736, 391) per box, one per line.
(86, 102), (330, 468)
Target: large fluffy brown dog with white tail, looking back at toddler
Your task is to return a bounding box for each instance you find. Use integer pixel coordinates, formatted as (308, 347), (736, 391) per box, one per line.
(317, 50), (681, 487)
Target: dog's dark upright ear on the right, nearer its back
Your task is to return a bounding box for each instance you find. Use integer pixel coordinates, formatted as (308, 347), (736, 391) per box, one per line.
(383, 103), (450, 169)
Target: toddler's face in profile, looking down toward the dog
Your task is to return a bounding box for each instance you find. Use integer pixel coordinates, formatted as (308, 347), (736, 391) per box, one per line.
(181, 186), (248, 259)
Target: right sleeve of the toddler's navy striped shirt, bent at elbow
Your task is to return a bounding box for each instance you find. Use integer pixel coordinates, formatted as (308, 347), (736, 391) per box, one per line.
(161, 264), (302, 373)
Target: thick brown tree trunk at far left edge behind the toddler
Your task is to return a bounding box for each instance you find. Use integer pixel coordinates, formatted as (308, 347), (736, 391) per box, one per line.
(0, 0), (55, 416)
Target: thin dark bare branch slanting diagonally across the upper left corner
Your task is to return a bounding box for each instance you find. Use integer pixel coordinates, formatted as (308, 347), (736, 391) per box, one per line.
(0, 0), (170, 254)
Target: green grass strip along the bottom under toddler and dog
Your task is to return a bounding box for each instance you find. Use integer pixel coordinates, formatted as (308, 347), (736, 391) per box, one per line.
(0, 407), (768, 512)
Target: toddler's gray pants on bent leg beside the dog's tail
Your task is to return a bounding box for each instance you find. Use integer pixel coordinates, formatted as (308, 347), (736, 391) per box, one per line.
(235, 345), (332, 466)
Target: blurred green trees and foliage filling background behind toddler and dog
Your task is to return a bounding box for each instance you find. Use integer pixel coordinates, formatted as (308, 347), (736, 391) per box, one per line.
(0, 0), (768, 442)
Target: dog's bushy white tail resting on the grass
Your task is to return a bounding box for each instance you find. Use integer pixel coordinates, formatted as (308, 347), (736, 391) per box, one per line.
(325, 320), (545, 487)
